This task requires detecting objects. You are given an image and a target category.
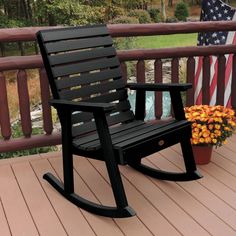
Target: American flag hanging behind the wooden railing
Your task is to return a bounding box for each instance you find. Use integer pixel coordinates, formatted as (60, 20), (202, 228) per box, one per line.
(195, 0), (236, 107)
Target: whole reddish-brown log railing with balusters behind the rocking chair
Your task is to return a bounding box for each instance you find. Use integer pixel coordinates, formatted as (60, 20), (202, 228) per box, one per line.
(0, 22), (236, 152)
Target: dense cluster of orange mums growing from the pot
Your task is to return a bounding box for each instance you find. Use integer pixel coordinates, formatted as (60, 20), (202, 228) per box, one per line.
(185, 105), (236, 146)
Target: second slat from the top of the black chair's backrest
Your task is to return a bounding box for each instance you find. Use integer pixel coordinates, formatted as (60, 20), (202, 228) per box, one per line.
(45, 36), (112, 53)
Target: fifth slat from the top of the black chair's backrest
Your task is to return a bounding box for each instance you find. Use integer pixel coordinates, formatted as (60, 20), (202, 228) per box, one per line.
(55, 68), (121, 89)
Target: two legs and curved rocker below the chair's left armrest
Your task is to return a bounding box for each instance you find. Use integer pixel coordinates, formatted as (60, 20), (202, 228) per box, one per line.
(43, 110), (135, 218)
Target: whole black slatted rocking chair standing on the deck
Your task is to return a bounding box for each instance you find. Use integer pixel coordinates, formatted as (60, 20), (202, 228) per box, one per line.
(37, 25), (201, 217)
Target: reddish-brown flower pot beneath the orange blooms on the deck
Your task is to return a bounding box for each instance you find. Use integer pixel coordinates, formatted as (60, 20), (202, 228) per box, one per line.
(192, 145), (212, 165)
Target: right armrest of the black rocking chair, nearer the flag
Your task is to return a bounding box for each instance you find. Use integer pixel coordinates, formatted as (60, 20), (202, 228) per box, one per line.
(126, 83), (192, 91)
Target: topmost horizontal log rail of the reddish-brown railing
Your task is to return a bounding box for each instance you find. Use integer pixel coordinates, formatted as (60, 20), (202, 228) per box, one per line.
(0, 21), (236, 42)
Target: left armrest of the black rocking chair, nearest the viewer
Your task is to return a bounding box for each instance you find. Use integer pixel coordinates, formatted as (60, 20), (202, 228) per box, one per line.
(49, 99), (115, 113)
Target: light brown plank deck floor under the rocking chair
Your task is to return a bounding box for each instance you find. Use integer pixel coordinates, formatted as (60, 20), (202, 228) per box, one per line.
(0, 135), (236, 236)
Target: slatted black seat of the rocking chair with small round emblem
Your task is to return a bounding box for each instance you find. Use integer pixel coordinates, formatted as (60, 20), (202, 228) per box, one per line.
(73, 120), (191, 164)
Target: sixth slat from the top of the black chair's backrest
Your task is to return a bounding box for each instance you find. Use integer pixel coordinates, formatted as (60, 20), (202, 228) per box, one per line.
(59, 79), (125, 100)
